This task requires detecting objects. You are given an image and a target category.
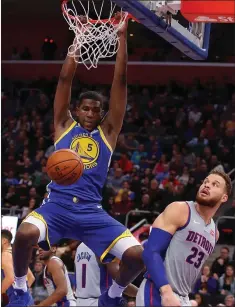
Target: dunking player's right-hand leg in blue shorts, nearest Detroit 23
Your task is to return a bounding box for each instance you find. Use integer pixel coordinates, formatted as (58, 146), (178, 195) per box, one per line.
(71, 206), (144, 306)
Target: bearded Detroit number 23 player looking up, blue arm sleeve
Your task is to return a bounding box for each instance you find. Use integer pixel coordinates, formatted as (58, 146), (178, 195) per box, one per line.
(136, 170), (231, 307)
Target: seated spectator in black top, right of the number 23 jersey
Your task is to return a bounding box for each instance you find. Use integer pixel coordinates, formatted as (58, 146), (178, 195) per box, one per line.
(211, 246), (230, 279)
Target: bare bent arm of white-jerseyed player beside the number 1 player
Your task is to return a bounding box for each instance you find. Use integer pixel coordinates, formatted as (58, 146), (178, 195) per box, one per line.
(37, 259), (68, 306)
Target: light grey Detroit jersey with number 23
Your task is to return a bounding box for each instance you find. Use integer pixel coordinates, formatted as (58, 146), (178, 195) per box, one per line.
(149, 201), (216, 296)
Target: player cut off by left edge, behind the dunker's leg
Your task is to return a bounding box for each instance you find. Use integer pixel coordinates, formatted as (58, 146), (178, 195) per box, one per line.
(1, 229), (35, 301)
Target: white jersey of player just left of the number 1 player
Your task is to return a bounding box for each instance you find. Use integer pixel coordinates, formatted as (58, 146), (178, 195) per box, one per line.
(43, 256), (76, 306)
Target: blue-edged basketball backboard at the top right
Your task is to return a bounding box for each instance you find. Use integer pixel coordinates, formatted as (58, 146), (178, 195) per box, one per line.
(112, 0), (211, 60)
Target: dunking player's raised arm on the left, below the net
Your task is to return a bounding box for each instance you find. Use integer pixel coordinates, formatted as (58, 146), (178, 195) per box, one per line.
(54, 49), (77, 141)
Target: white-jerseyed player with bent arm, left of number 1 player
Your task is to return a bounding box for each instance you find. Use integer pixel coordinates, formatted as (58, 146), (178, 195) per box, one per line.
(37, 245), (76, 307)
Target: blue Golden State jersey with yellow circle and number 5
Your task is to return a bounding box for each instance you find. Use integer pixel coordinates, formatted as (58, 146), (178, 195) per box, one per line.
(48, 121), (112, 203)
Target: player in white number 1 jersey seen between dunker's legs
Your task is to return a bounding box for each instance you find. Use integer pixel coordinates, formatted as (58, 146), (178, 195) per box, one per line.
(74, 243), (138, 306)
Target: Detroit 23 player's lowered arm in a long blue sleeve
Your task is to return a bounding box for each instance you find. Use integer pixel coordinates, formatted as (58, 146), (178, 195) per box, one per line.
(143, 202), (189, 306)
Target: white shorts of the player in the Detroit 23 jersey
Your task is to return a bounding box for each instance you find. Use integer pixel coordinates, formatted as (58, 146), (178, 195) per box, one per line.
(136, 278), (191, 307)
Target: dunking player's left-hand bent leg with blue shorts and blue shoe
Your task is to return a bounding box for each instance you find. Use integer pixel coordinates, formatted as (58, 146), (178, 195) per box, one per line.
(8, 202), (70, 307)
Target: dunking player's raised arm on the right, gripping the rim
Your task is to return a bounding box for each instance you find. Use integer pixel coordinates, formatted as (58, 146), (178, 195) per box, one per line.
(101, 13), (127, 148)
